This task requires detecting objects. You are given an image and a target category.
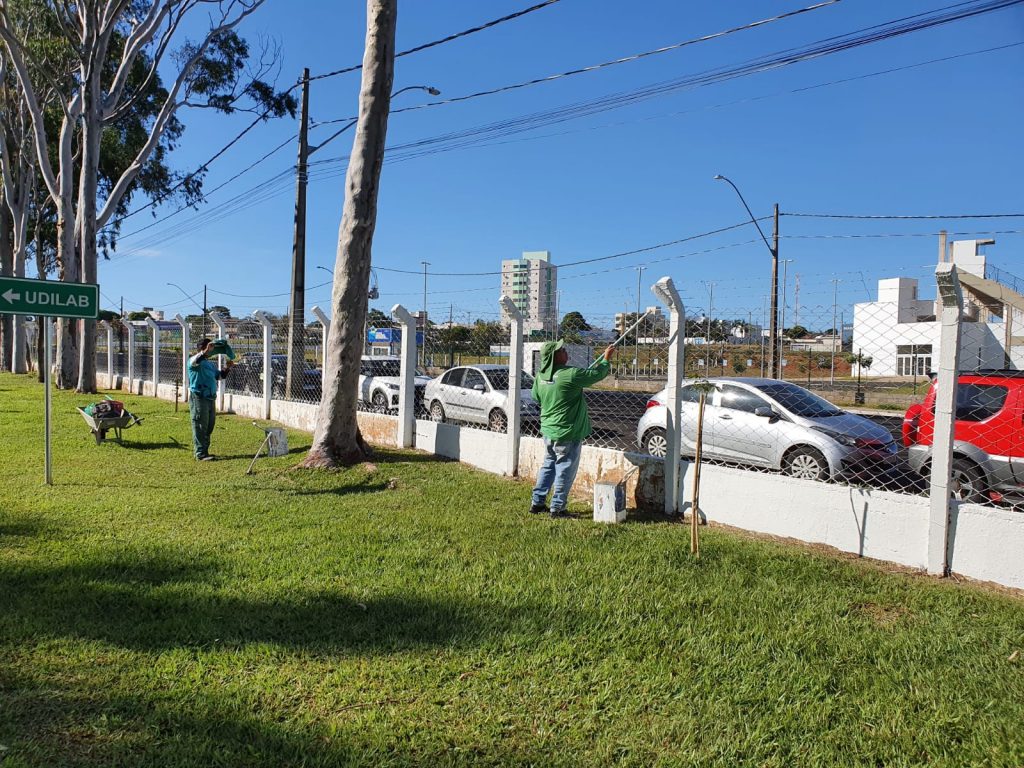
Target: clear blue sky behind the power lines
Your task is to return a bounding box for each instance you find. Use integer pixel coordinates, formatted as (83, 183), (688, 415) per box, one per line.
(99, 0), (1024, 328)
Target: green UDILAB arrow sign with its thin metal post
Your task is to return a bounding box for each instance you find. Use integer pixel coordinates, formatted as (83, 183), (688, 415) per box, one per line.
(0, 278), (99, 485)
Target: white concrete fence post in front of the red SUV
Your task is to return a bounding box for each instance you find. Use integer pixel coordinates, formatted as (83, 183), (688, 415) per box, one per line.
(928, 262), (964, 575)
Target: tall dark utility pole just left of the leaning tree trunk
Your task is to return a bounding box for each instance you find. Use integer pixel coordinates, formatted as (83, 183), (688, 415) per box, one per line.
(286, 68), (309, 398)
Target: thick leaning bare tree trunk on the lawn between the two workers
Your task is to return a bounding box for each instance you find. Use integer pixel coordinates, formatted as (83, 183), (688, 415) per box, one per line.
(303, 0), (398, 467)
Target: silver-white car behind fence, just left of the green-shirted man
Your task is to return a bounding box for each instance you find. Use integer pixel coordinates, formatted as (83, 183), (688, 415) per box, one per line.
(423, 366), (541, 432)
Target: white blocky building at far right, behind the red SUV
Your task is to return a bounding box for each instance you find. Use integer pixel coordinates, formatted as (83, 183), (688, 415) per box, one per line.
(852, 240), (1024, 377)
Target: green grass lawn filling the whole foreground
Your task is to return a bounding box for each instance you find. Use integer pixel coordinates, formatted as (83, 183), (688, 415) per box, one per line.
(0, 375), (1024, 768)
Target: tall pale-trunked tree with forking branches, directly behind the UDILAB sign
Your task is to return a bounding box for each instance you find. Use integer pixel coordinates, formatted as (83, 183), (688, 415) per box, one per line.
(0, 0), (295, 391)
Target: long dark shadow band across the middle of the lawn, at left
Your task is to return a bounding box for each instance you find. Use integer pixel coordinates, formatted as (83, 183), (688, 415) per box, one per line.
(0, 551), (580, 654)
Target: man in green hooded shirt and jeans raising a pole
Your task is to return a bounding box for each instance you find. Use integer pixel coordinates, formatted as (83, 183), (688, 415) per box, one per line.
(529, 339), (614, 517)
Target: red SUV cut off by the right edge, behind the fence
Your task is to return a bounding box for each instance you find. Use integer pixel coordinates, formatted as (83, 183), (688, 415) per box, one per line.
(903, 371), (1024, 503)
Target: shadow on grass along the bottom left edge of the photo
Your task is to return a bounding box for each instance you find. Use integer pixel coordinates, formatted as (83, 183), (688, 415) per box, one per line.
(0, 665), (564, 768)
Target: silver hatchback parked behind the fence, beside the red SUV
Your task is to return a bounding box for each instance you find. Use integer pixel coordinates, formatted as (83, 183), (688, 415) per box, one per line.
(637, 377), (899, 480)
